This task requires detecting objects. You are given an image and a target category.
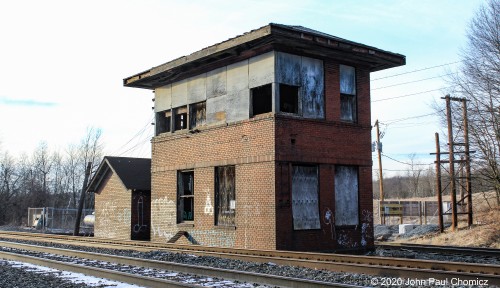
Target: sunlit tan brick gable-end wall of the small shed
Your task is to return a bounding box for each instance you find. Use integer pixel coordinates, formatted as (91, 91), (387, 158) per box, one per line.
(94, 172), (132, 240)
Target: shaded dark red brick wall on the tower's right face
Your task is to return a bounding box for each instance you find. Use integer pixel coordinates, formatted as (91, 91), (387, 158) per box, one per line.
(276, 61), (373, 250)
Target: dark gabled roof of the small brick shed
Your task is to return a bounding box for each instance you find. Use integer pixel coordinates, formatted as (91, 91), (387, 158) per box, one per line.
(87, 156), (151, 192)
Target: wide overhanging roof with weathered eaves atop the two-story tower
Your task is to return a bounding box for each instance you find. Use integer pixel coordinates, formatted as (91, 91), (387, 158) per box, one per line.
(123, 23), (406, 89)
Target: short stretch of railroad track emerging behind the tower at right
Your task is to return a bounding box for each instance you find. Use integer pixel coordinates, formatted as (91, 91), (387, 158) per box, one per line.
(375, 242), (500, 258)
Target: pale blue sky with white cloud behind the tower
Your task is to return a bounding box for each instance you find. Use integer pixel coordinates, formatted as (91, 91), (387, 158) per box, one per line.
(0, 0), (485, 173)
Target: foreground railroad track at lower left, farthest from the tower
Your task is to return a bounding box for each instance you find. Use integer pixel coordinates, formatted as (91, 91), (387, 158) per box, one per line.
(0, 242), (352, 288)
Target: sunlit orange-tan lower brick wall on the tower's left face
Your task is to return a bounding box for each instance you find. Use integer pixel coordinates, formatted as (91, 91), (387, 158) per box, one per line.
(151, 115), (276, 249)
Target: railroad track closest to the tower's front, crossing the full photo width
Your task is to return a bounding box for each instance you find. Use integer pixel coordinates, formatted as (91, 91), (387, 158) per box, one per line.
(0, 232), (500, 285)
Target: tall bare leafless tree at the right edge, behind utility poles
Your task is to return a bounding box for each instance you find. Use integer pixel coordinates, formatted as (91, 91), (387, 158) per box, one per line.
(451, 0), (500, 203)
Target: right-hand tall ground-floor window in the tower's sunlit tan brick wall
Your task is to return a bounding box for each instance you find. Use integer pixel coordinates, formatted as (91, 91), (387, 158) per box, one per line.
(215, 166), (236, 226)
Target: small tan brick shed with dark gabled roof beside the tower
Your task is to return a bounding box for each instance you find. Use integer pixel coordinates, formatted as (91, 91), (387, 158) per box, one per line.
(87, 156), (151, 240)
